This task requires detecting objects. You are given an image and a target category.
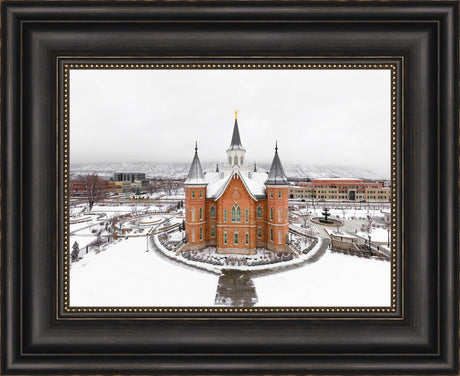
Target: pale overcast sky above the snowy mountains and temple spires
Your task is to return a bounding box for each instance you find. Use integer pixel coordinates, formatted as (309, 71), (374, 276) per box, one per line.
(70, 69), (391, 177)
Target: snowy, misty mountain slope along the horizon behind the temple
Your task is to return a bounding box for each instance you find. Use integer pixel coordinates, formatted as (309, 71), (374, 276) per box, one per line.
(70, 162), (385, 179)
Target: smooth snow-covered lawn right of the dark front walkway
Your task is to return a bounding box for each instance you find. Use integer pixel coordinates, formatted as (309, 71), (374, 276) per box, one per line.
(253, 251), (391, 307)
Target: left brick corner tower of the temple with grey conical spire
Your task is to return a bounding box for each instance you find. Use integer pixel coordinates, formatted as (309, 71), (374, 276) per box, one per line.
(184, 143), (208, 249)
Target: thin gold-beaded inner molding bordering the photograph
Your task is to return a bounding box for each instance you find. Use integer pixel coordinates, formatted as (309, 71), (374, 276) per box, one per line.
(60, 57), (398, 320)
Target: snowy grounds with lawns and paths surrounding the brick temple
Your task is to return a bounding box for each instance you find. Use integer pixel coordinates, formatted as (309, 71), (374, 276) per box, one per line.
(70, 201), (391, 307)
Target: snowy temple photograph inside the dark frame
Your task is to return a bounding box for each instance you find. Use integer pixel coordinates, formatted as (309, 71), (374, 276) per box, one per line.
(67, 65), (399, 312)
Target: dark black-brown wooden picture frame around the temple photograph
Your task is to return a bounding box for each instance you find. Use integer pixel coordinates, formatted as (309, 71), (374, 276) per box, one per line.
(1, 1), (459, 375)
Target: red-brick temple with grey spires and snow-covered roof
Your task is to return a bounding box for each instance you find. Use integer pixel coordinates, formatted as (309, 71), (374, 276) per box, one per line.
(184, 112), (289, 255)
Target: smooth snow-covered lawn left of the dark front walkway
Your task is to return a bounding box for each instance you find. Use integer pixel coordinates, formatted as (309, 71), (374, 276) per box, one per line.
(70, 237), (219, 307)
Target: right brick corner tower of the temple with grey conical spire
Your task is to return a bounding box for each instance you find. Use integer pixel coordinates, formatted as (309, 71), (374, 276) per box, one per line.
(265, 143), (289, 252)
